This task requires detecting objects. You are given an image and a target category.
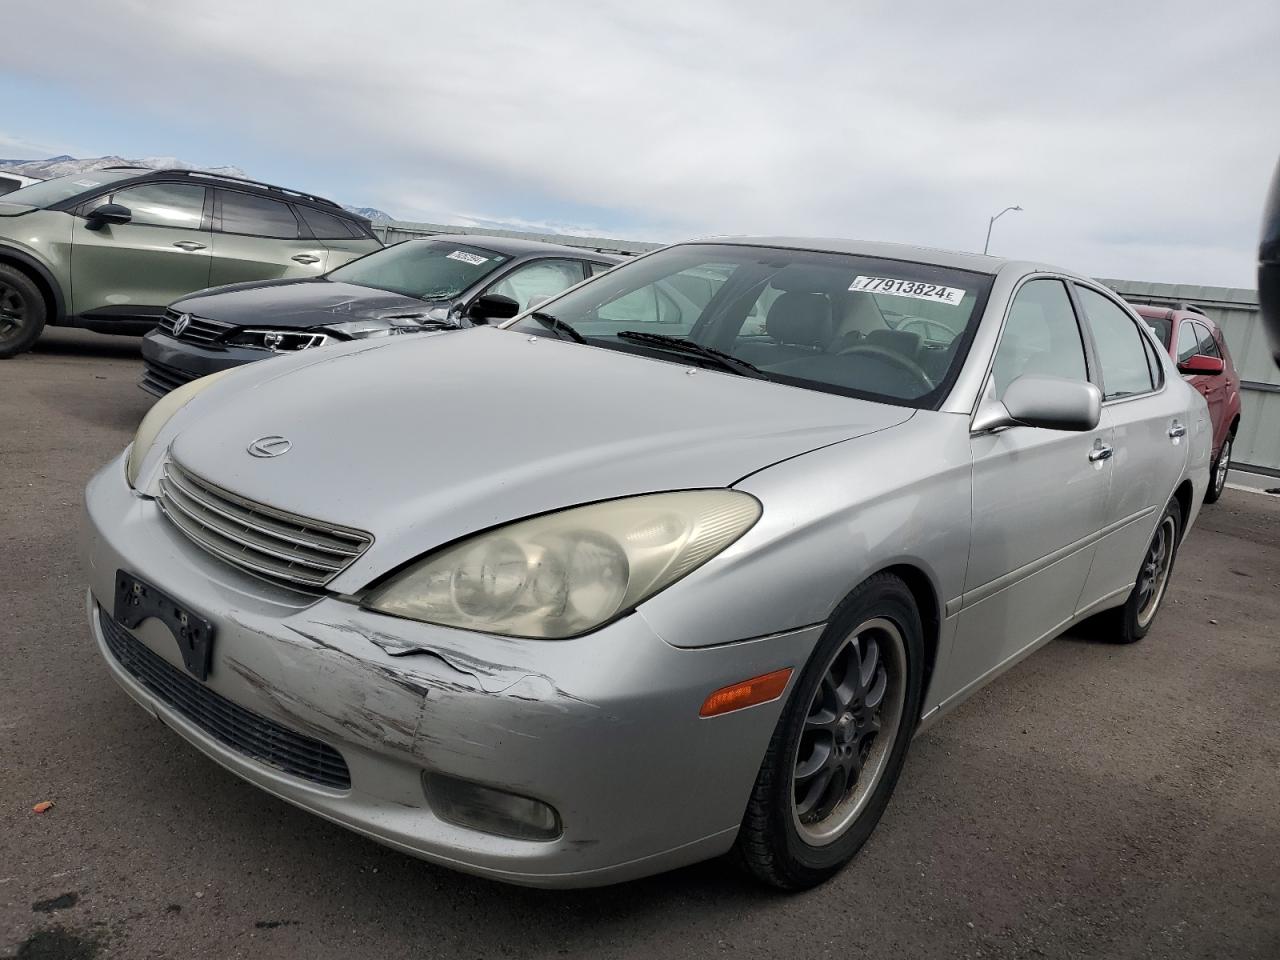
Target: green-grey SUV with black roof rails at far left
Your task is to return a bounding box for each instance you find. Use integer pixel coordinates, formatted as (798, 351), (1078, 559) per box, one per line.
(0, 166), (381, 357)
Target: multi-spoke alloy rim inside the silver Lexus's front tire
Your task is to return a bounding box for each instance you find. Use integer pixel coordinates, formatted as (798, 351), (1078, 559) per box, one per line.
(791, 618), (906, 846)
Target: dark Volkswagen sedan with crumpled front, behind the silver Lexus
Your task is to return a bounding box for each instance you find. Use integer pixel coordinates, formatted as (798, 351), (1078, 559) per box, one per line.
(140, 234), (621, 397)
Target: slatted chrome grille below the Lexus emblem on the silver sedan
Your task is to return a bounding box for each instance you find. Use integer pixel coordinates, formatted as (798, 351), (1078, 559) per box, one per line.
(160, 460), (374, 593)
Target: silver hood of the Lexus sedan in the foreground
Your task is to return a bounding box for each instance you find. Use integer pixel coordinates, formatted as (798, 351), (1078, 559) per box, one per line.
(170, 328), (913, 591)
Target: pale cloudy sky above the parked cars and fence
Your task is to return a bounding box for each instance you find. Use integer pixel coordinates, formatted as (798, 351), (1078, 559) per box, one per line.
(0, 0), (1280, 287)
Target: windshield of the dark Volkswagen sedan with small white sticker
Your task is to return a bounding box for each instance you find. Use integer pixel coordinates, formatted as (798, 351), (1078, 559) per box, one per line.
(328, 241), (511, 300)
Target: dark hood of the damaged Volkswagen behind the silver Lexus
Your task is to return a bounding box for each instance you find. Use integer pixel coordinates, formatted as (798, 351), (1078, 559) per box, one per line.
(173, 278), (430, 329)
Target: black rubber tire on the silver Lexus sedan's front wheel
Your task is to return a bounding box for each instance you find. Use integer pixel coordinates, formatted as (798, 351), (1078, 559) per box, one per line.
(735, 573), (924, 890)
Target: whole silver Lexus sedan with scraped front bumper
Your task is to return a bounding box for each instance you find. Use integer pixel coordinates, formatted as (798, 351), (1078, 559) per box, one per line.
(86, 239), (1211, 888)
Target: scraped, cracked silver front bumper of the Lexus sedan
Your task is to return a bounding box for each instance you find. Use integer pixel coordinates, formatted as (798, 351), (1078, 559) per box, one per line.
(84, 460), (819, 887)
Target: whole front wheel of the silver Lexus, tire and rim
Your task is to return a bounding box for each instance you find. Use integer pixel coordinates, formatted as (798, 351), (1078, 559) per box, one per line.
(736, 573), (924, 890)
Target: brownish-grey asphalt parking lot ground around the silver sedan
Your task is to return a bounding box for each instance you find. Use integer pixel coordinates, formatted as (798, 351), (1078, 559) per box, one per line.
(0, 330), (1280, 960)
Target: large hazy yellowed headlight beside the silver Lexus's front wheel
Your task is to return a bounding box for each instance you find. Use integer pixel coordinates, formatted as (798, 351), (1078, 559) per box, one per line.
(364, 490), (760, 640)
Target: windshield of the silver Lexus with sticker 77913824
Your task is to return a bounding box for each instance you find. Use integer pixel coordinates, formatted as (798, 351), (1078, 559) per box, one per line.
(508, 243), (992, 407)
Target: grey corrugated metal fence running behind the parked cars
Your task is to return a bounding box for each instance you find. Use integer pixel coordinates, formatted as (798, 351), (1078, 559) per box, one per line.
(374, 220), (1280, 475)
